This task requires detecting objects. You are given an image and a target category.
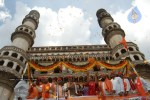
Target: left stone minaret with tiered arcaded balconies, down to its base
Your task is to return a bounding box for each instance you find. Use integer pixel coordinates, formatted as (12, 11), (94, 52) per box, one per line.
(0, 10), (40, 100)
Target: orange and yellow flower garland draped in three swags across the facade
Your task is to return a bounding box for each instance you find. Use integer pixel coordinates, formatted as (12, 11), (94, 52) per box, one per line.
(29, 59), (128, 72)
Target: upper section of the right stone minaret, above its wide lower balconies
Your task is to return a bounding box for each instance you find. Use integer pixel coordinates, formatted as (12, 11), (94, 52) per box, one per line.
(96, 9), (125, 48)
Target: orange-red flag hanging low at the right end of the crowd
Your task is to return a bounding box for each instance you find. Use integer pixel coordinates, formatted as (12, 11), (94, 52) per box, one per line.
(136, 77), (146, 96)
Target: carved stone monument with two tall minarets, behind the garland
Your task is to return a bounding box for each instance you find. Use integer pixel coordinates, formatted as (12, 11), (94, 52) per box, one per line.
(0, 9), (150, 100)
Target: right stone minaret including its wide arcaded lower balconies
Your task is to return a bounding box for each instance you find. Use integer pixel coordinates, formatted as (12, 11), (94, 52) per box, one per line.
(96, 9), (145, 64)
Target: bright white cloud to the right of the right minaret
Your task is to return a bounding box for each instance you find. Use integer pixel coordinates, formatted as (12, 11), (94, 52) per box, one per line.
(112, 0), (150, 59)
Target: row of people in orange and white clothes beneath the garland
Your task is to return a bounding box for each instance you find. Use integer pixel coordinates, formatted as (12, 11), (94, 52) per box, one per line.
(14, 72), (150, 100)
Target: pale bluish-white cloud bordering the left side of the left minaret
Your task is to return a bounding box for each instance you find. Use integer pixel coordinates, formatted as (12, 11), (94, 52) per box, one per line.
(0, 2), (30, 47)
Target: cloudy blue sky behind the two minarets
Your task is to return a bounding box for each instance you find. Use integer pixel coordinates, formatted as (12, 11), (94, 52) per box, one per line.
(0, 0), (150, 59)
